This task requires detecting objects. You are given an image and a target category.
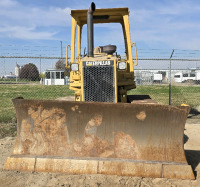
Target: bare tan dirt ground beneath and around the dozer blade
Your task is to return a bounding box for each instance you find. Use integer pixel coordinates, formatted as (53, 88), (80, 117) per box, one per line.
(0, 115), (200, 187)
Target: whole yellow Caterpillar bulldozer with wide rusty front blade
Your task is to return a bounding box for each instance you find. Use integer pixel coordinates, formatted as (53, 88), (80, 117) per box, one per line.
(4, 3), (195, 179)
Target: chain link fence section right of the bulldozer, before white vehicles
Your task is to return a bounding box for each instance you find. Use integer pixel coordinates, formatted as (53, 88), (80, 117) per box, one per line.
(130, 59), (200, 109)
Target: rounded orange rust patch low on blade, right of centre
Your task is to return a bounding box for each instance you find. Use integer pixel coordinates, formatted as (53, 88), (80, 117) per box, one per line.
(114, 132), (138, 159)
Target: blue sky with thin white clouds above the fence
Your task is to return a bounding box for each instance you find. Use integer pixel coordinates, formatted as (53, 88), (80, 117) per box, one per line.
(0, 0), (200, 54)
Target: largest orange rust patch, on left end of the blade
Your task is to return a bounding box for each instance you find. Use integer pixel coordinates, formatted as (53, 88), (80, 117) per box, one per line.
(14, 107), (68, 155)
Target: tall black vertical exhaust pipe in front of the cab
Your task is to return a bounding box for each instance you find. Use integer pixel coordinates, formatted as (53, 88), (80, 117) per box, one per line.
(87, 2), (96, 57)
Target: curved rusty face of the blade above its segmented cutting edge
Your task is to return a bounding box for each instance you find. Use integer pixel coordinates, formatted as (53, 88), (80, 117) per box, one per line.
(3, 99), (194, 179)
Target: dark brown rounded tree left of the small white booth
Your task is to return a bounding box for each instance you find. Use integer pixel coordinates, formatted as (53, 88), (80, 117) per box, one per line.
(19, 63), (39, 81)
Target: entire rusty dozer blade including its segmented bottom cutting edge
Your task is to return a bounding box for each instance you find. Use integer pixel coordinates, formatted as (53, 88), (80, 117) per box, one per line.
(4, 99), (194, 179)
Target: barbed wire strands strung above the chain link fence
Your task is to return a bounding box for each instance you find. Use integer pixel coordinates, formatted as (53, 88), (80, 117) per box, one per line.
(0, 44), (200, 59)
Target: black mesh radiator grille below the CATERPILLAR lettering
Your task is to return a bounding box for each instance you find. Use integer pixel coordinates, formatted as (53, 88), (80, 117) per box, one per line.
(83, 66), (115, 102)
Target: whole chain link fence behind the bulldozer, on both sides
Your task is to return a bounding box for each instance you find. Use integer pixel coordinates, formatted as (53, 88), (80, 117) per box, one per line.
(0, 46), (200, 122)
